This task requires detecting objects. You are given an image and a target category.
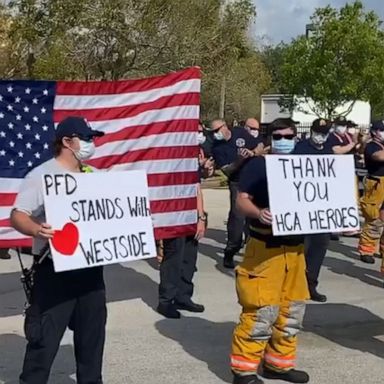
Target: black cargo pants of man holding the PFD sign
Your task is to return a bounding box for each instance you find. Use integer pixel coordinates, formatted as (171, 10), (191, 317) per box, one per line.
(20, 259), (107, 384)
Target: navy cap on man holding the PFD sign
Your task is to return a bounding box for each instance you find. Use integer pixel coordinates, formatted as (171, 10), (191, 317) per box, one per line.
(55, 116), (104, 140)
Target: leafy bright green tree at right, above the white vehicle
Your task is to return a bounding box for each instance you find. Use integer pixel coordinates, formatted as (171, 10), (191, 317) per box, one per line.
(282, 1), (384, 118)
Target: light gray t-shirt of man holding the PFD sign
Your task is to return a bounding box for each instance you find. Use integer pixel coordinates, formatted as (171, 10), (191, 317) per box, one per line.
(14, 159), (86, 255)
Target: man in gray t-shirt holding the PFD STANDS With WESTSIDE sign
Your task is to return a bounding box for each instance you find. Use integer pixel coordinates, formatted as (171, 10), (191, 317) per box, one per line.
(11, 117), (107, 384)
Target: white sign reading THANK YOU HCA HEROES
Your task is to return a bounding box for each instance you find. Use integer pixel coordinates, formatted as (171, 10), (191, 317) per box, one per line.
(266, 155), (360, 236)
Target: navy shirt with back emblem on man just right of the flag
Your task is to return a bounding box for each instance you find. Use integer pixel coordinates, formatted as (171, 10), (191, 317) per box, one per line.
(212, 127), (262, 181)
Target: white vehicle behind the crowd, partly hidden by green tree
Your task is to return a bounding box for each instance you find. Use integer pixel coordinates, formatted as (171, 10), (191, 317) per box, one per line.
(261, 94), (371, 128)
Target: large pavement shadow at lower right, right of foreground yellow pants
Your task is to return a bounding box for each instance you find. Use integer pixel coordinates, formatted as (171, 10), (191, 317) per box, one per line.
(304, 304), (384, 358)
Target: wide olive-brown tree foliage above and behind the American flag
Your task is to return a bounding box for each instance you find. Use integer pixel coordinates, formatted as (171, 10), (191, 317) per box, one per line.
(0, 0), (269, 118)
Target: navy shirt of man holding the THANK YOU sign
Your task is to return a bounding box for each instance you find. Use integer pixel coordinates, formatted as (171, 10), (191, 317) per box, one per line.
(239, 156), (304, 247)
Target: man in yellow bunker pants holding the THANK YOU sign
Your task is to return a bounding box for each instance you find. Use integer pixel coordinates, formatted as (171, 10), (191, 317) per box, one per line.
(231, 119), (309, 384)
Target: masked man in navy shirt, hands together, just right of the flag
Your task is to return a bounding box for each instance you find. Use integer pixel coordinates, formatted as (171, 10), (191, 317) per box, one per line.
(211, 119), (264, 269)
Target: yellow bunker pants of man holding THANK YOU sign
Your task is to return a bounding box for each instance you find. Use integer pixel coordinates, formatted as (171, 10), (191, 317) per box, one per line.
(231, 238), (309, 375)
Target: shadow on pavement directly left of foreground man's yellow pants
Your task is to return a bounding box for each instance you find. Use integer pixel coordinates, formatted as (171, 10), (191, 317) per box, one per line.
(155, 317), (236, 383)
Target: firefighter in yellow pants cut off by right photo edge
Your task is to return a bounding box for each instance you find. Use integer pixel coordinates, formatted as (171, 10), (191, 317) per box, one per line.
(358, 121), (384, 264)
